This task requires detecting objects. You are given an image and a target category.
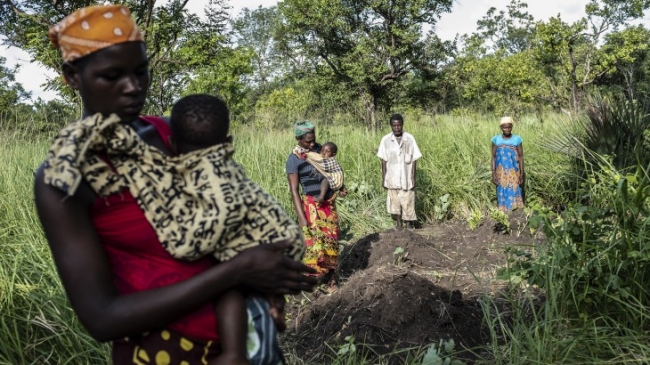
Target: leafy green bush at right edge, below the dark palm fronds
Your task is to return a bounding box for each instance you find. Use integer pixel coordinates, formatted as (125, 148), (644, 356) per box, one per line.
(500, 160), (650, 330)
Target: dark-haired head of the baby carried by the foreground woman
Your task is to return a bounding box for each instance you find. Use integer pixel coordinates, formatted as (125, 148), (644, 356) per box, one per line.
(170, 94), (232, 153)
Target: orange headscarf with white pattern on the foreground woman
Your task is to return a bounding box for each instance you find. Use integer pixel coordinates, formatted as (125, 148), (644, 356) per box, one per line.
(49, 5), (144, 62)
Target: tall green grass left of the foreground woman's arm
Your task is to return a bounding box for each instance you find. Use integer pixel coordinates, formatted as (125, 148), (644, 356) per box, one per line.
(0, 130), (108, 365)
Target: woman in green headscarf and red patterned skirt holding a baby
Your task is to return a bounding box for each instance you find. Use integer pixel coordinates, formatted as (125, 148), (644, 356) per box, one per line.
(286, 121), (339, 292)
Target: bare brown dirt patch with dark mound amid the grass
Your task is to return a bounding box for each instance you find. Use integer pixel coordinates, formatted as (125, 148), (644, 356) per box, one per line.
(282, 214), (535, 363)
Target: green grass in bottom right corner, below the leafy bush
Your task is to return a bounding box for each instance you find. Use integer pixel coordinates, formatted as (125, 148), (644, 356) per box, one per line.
(477, 282), (650, 365)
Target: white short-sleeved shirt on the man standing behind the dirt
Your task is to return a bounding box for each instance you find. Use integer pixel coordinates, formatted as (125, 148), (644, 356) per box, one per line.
(377, 132), (422, 190)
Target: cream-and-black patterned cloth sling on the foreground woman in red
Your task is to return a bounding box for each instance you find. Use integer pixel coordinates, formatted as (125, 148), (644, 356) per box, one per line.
(44, 114), (304, 261)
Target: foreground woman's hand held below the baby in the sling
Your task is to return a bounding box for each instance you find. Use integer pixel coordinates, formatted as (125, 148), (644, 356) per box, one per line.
(231, 241), (318, 294)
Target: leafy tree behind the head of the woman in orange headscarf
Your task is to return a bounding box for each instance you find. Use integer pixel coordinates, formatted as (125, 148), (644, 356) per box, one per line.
(0, 0), (250, 114)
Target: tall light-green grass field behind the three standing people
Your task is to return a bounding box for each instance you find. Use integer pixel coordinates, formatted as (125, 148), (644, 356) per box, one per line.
(233, 115), (570, 228)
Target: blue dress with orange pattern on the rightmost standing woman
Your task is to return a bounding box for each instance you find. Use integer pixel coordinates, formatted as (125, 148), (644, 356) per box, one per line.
(492, 134), (524, 212)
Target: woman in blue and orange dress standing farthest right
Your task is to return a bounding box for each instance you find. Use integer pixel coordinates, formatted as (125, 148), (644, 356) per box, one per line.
(492, 117), (524, 212)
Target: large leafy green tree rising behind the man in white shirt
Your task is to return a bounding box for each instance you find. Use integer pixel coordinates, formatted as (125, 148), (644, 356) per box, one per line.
(277, 0), (452, 126)
